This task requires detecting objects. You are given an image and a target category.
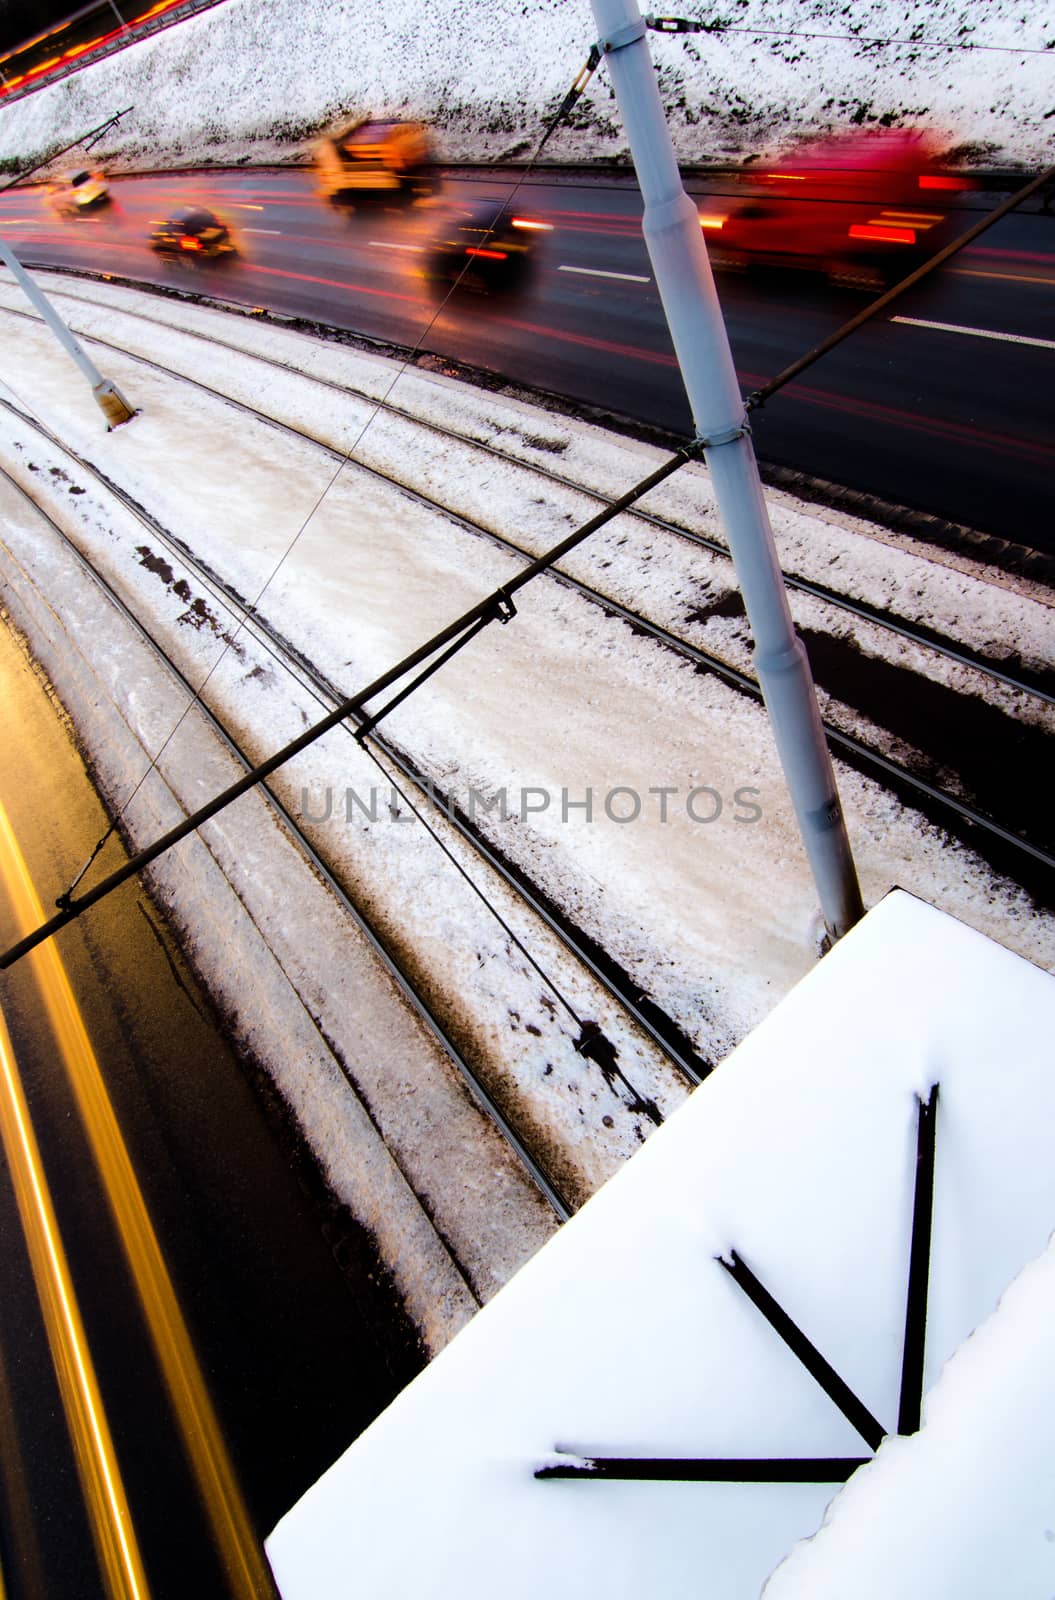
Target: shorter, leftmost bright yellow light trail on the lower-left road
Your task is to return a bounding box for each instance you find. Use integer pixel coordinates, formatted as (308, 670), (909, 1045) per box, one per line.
(0, 1013), (150, 1600)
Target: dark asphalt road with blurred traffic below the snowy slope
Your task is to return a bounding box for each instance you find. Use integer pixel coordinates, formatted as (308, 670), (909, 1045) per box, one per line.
(0, 170), (1055, 554)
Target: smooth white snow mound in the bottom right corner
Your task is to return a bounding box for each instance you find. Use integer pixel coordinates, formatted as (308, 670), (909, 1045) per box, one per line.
(762, 1245), (1055, 1600)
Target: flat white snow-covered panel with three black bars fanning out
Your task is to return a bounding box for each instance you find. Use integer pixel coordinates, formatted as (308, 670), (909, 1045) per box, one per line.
(267, 891), (1055, 1600)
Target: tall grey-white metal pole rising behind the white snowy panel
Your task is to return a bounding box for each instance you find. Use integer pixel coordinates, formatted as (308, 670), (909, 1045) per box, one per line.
(592, 0), (864, 939)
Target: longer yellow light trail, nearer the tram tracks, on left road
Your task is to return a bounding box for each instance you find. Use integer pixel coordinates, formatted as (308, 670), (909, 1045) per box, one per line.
(0, 805), (277, 1600)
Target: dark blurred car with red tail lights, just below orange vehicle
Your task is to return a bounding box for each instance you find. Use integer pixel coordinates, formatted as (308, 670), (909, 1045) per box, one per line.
(424, 200), (552, 294)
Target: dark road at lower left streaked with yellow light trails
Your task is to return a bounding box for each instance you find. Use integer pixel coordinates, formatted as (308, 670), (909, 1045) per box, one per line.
(0, 614), (421, 1600)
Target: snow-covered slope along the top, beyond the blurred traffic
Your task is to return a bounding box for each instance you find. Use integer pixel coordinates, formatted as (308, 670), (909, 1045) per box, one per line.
(0, 0), (1055, 177)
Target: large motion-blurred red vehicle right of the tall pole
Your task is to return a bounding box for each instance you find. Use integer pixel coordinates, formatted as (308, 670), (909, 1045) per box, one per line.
(700, 130), (973, 290)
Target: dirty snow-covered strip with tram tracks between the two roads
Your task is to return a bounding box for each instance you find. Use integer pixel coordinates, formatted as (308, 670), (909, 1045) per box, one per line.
(0, 275), (1055, 1349)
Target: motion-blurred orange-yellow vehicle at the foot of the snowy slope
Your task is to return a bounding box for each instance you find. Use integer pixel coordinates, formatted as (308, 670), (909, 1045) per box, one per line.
(315, 120), (437, 205)
